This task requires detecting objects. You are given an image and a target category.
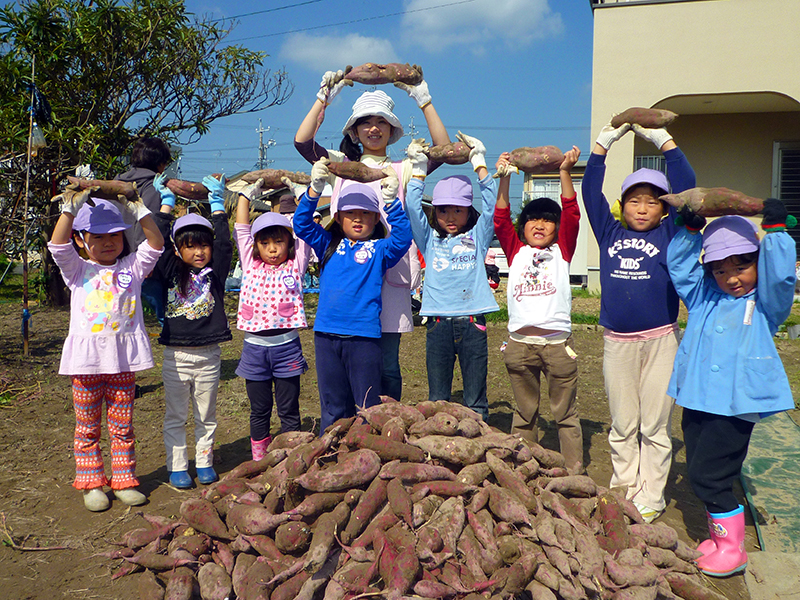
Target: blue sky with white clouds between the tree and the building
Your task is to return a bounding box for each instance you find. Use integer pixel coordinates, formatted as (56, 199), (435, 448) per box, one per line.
(180, 0), (592, 204)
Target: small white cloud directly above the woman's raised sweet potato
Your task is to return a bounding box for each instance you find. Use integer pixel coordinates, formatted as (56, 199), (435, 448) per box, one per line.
(279, 33), (399, 73)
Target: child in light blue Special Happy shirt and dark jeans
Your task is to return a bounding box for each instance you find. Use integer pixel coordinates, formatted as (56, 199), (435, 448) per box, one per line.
(406, 132), (498, 421)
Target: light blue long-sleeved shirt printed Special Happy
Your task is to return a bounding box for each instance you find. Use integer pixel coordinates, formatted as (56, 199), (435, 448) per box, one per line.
(406, 175), (499, 317)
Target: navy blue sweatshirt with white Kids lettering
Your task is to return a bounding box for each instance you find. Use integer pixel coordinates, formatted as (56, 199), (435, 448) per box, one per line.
(581, 148), (695, 333)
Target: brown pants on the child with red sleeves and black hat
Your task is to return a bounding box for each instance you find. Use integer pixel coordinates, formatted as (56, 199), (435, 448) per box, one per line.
(503, 340), (583, 471)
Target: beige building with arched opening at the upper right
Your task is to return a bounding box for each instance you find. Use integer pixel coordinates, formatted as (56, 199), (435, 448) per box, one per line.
(587, 0), (800, 289)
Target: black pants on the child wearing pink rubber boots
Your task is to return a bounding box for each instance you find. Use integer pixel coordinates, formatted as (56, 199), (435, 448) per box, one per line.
(681, 408), (754, 513)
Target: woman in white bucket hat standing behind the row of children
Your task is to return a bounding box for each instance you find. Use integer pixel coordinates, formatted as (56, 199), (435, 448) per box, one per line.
(294, 71), (450, 400)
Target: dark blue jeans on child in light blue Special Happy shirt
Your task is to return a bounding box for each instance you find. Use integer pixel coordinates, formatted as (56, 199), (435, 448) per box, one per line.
(425, 315), (489, 421)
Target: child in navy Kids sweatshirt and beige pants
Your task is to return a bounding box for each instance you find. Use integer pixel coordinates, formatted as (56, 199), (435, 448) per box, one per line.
(582, 123), (695, 522)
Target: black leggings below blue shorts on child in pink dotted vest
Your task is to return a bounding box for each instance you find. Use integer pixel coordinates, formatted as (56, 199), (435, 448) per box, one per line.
(245, 375), (300, 440)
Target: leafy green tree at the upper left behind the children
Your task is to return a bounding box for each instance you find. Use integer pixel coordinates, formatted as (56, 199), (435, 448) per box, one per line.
(0, 0), (293, 302)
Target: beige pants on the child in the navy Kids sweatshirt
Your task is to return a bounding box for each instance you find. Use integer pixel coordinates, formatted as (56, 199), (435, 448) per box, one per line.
(603, 332), (678, 510)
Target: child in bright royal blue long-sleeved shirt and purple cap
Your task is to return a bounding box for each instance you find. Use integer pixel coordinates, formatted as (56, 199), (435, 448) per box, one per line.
(294, 160), (411, 435)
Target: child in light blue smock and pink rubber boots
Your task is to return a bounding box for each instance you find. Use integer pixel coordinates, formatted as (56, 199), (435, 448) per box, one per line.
(667, 205), (796, 577)
